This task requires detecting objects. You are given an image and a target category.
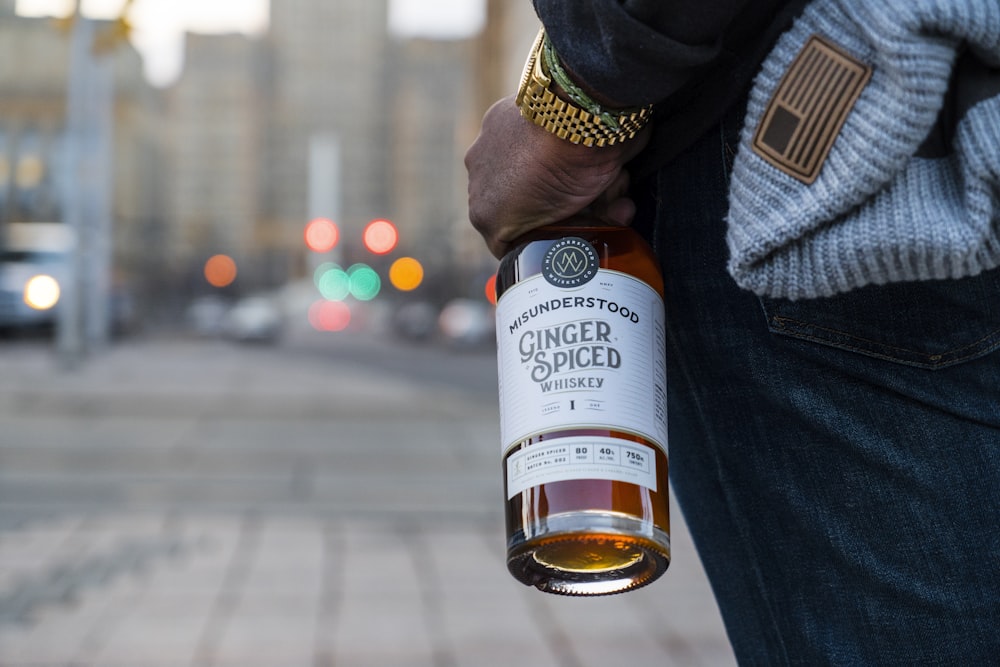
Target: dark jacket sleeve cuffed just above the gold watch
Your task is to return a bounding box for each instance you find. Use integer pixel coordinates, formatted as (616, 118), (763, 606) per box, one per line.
(534, 0), (783, 106)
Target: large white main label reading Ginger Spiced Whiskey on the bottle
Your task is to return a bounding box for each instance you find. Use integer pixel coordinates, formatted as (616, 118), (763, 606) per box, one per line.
(496, 269), (667, 464)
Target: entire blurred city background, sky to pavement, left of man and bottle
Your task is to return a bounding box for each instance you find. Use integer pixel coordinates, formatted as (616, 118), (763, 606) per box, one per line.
(0, 0), (735, 667)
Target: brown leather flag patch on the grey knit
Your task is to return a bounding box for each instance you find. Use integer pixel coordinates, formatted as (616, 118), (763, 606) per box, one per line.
(753, 35), (872, 184)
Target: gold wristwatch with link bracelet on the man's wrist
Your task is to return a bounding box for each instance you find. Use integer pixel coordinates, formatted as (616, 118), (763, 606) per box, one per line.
(514, 29), (652, 146)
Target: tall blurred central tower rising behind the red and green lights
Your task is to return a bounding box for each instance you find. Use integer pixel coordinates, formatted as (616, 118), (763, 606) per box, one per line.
(262, 0), (390, 284)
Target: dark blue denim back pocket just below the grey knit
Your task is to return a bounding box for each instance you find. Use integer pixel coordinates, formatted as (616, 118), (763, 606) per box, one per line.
(761, 269), (1000, 369)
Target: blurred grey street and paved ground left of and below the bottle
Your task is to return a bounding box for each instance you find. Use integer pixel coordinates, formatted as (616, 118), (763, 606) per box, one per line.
(0, 331), (735, 667)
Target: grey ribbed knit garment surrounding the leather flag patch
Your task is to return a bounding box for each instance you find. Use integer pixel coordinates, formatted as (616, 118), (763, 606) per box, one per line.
(727, 0), (1000, 299)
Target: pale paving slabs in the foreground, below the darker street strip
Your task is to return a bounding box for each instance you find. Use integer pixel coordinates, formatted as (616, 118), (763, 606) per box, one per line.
(0, 514), (734, 667)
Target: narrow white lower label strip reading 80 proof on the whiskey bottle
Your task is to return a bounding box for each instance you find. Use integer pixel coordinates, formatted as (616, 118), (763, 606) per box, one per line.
(507, 436), (657, 500)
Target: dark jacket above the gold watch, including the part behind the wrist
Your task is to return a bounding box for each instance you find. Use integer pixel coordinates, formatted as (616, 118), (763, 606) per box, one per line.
(536, 0), (808, 171)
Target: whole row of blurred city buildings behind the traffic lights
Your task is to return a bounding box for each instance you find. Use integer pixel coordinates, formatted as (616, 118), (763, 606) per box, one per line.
(0, 0), (537, 322)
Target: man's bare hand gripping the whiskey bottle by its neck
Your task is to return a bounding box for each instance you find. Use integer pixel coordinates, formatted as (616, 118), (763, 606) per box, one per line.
(465, 97), (649, 258)
